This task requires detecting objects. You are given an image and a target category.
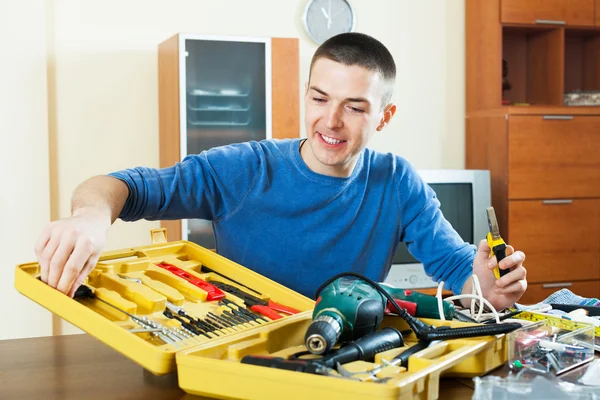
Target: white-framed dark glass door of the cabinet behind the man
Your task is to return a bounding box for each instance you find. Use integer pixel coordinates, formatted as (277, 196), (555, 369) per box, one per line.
(182, 37), (272, 248)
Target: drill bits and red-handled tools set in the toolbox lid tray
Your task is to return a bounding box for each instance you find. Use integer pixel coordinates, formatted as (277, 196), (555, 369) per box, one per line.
(69, 257), (300, 348)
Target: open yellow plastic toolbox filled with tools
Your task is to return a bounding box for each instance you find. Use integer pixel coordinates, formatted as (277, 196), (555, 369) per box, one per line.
(15, 229), (507, 400)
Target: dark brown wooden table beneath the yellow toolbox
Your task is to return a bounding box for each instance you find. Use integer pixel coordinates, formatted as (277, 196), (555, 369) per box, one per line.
(0, 334), (486, 400)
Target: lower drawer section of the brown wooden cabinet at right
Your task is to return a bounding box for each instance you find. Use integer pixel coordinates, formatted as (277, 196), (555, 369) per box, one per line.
(466, 110), (600, 302)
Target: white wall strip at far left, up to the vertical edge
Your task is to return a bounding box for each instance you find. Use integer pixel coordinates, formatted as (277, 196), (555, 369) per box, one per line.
(0, 0), (52, 339)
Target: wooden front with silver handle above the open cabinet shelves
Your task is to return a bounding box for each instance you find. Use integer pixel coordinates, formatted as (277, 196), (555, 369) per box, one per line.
(500, 0), (595, 26)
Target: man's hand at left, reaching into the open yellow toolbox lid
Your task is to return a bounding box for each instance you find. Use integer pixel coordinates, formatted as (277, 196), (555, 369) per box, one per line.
(35, 208), (112, 297)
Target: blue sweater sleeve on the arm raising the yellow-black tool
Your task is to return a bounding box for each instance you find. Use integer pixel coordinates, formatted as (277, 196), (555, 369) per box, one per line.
(399, 162), (477, 294)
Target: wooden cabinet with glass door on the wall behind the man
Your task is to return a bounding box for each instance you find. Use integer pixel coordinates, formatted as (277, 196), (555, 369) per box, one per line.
(158, 34), (300, 244)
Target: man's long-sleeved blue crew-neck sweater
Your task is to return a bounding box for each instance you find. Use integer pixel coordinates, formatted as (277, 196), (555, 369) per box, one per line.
(110, 139), (476, 298)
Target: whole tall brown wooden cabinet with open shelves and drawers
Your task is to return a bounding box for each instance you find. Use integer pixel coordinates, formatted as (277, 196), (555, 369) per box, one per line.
(465, 0), (600, 304)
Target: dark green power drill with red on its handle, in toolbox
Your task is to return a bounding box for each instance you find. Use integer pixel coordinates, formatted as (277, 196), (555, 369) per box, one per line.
(304, 277), (455, 354)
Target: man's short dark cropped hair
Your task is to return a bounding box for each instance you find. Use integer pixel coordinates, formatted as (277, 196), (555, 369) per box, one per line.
(309, 32), (396, 107)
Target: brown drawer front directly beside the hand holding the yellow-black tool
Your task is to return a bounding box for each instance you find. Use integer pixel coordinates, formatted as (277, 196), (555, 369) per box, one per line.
(508, 199), (600, 283)
